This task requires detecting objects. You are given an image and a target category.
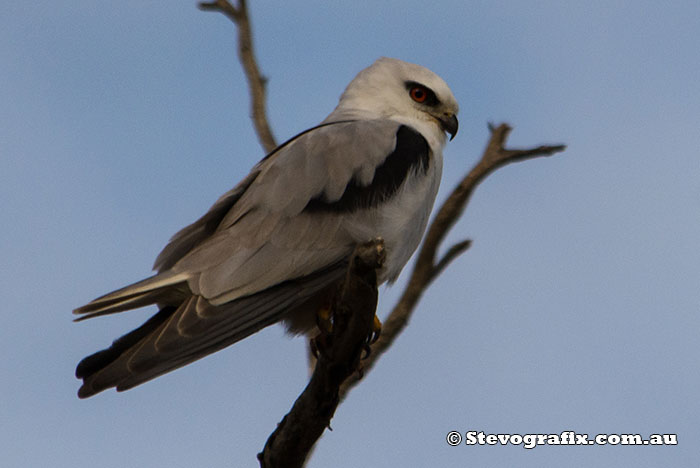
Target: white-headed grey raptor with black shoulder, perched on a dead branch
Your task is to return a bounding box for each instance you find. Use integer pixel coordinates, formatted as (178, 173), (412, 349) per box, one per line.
(73, 57), (459, 398)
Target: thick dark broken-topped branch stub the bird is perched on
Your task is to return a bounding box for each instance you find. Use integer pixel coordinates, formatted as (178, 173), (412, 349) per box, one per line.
(258, 239), (385, 468)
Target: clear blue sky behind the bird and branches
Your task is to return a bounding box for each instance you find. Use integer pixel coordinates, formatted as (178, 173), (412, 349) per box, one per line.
(0, 1), (700, 468)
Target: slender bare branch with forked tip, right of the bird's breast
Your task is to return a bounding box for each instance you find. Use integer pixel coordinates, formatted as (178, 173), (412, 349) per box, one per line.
(341, 124), (566, 398)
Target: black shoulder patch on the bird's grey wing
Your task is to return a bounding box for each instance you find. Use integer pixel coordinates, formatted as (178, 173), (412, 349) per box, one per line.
(304, 125), (430, 212)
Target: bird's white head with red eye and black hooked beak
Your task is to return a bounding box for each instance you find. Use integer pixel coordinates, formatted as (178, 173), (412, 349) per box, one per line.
(334, 57), (459, 141)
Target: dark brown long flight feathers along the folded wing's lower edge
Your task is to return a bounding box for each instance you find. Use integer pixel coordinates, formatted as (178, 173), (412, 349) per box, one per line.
(77, 261), (347, 398)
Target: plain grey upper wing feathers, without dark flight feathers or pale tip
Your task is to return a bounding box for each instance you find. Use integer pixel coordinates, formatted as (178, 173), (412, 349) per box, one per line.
(161, 120), (399, 305)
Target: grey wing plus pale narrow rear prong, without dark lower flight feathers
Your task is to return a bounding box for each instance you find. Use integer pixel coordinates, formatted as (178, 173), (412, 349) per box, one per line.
(74, 121), (398, 320)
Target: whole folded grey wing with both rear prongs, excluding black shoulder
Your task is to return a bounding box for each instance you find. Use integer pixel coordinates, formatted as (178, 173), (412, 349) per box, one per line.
(76, 121), (398, 397)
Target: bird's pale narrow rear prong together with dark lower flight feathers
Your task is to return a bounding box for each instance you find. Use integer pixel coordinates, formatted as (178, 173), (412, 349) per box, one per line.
(75, 259), (347, 398)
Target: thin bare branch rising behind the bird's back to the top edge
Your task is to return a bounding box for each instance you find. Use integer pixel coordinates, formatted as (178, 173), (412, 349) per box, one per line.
(197, 0), (277, 153)
